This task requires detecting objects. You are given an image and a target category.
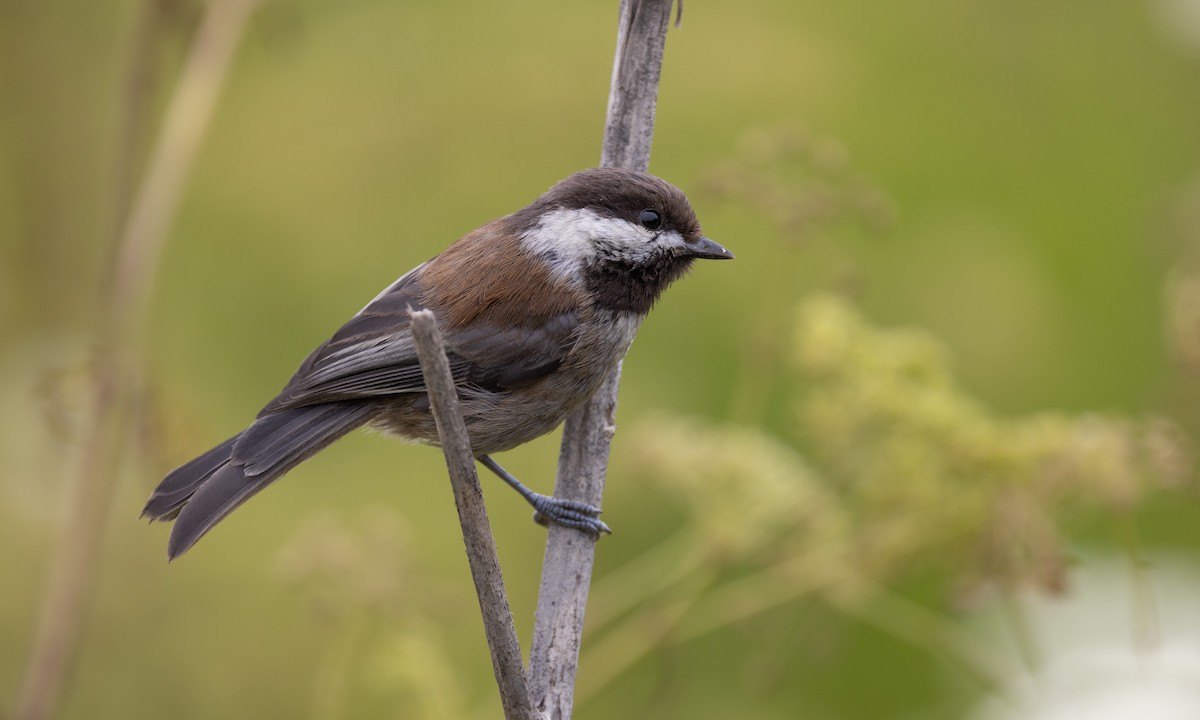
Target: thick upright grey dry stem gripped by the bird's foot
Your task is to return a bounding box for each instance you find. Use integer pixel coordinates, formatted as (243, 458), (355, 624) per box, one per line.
(529, 0), (672, 720)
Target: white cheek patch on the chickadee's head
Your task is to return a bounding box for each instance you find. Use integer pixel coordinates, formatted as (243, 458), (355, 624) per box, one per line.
(521, 208), (657, 277)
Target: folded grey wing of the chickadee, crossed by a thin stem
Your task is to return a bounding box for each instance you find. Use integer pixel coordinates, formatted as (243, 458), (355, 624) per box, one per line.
(259, 266), (578, 416)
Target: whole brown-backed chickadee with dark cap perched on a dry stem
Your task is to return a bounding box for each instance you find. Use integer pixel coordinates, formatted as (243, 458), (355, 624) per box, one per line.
(142, 168), (733, 559)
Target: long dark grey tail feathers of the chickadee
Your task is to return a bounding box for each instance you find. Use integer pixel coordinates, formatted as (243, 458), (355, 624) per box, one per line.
(142, 402), (376, 559)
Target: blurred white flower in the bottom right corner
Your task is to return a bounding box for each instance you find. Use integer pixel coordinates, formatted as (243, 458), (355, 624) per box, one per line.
(972, 558), (1200, 720)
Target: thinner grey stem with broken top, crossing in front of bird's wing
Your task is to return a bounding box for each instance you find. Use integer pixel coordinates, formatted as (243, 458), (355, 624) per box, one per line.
(413, 310), (539, 720)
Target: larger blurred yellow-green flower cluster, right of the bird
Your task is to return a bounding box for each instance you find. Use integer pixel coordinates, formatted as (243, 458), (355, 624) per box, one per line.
(796, 296), (1192, 592)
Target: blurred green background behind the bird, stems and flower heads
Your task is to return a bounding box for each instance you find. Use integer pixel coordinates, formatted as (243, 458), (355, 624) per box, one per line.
(0, 0), (1200, 719)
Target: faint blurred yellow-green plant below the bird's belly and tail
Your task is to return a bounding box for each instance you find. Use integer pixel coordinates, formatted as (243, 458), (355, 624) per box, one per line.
(277, 508), (477, 719)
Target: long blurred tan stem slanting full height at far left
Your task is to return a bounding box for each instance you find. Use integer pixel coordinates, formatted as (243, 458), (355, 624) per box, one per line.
(16, 0), (254, 720)
